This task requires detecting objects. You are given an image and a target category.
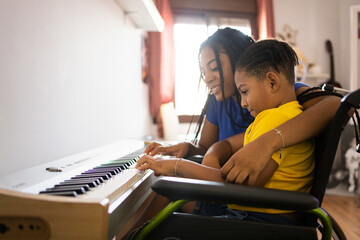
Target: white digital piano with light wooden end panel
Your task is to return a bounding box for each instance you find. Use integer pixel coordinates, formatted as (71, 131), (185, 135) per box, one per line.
(0, 140), (156, 240)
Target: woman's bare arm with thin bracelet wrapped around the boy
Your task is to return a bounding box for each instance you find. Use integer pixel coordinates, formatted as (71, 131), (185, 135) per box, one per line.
(221, 87), (340, 185)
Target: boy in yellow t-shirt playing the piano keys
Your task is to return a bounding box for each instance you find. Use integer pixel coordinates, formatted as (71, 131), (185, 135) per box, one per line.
(137, 40), (314, 223)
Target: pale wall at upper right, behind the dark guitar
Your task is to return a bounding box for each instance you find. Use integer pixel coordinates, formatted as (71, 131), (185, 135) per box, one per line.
(273, 0), (360, 89)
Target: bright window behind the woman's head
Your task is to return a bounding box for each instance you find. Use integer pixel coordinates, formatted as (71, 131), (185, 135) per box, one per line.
(174, 14), (252, 115)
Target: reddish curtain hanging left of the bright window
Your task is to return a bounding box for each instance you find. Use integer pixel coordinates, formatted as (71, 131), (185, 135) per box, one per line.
(148, 0), (175, 137)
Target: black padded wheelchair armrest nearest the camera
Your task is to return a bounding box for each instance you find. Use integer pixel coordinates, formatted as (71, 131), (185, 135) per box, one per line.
(152, 177), (319, 211)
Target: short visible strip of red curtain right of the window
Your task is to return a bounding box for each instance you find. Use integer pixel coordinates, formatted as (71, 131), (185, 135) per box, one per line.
(257, 0), (275, 39)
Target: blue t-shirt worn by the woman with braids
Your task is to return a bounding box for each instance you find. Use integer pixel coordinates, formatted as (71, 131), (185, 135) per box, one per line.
(206, 82), (307, 141)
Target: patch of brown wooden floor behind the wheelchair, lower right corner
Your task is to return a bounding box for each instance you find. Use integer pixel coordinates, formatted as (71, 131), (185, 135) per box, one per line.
(322, 194), (360, 240)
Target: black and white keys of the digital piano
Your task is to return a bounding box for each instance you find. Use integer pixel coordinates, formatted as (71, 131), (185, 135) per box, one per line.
(39, 149), (143, 197)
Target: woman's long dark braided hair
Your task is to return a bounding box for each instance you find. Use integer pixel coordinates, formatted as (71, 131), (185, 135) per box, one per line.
(190, 27), (255, 144)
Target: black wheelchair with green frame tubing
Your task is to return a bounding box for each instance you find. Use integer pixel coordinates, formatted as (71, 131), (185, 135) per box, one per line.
(135, 89), (360, 240)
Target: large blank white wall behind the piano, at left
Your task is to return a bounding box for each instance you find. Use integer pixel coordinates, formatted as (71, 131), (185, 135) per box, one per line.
(0, 0), (151, 176)
